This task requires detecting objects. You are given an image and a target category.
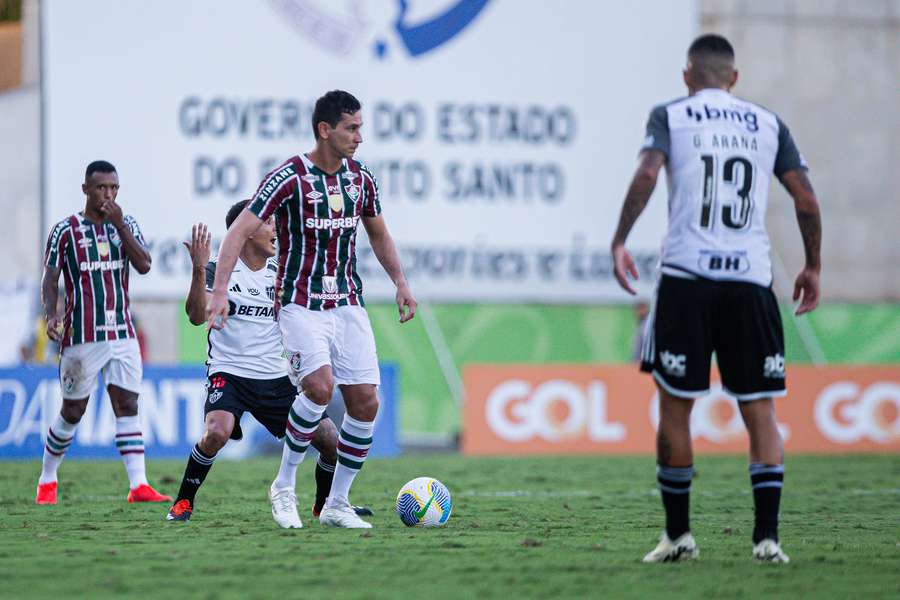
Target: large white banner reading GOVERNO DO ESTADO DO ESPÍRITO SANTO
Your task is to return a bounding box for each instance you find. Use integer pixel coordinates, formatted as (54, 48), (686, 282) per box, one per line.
(42, 0), (697, 302)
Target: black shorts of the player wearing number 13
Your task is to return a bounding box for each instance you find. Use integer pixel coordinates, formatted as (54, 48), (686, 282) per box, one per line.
(641, 275), (785, 400)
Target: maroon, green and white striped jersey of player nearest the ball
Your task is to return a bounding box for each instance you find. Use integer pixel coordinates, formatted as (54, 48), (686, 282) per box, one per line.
(249, 155), (381, 310)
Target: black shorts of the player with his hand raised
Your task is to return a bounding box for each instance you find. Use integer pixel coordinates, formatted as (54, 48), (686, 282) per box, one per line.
(203, 372), (326, 440)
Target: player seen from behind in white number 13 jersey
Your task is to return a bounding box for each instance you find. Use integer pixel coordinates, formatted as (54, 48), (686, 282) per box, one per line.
(612, 35), (821, 562)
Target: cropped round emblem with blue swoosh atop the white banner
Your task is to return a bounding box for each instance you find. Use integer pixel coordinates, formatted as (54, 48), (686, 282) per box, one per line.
(269, 0), (489, 60)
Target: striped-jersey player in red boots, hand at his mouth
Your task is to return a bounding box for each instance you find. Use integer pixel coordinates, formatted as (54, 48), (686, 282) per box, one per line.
(35, 160), (171, 504)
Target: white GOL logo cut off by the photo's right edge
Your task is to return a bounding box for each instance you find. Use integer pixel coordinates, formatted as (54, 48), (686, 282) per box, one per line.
(815, 381), (900, 444)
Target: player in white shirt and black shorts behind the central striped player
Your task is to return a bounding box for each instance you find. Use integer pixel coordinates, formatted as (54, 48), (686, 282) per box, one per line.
(166, 200), (372, 528)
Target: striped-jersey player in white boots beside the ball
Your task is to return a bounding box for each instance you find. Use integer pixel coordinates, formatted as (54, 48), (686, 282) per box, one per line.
(208, 91), (416, 528)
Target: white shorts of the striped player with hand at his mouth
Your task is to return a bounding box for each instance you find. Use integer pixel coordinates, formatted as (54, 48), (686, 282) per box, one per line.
(59, 338), (144, 400)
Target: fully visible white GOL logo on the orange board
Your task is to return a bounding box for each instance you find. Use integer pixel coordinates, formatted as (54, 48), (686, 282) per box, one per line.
(485, 379), (626, 442)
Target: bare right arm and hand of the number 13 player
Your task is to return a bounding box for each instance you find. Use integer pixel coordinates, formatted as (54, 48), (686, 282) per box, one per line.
(781, 169), (822, 315)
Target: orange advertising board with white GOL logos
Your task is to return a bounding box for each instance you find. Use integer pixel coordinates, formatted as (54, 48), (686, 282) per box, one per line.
(462, 365), (900, 455)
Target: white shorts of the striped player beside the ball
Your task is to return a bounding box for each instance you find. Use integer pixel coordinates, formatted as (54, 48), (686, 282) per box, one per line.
(278, 304), (381, 385)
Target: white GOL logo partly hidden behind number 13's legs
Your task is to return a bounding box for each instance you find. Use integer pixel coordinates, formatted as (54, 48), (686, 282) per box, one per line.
(650, 383), (790, 444)
